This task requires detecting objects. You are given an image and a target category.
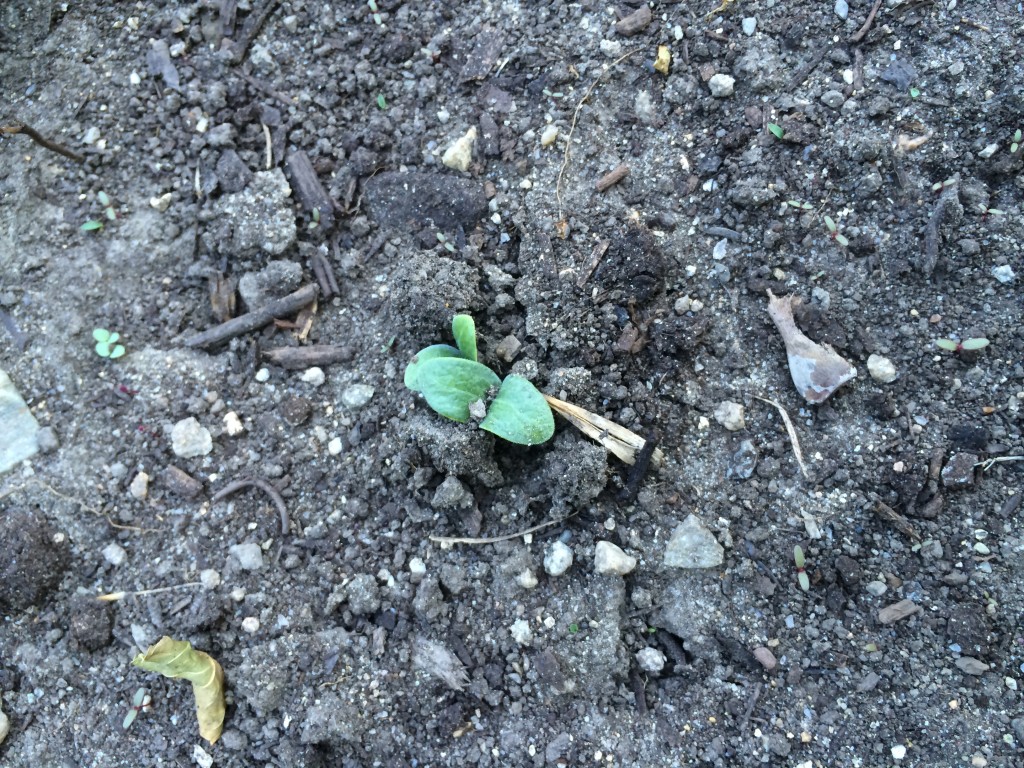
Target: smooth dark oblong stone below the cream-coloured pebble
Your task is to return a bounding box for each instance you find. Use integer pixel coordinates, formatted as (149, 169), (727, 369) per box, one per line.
(364, 171), (487, 232)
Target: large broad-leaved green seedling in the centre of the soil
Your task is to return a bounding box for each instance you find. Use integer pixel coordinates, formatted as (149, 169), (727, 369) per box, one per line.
(406, 314), (555, 445)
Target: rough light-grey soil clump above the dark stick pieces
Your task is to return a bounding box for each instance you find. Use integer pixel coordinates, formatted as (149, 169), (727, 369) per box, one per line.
(210, 168), (297, 259)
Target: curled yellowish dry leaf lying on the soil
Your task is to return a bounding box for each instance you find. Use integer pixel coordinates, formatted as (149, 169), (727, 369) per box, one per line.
(132, 636), (224, 744)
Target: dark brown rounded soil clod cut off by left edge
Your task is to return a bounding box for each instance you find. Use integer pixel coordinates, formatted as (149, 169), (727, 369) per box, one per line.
(0, 506), (68, 613)
